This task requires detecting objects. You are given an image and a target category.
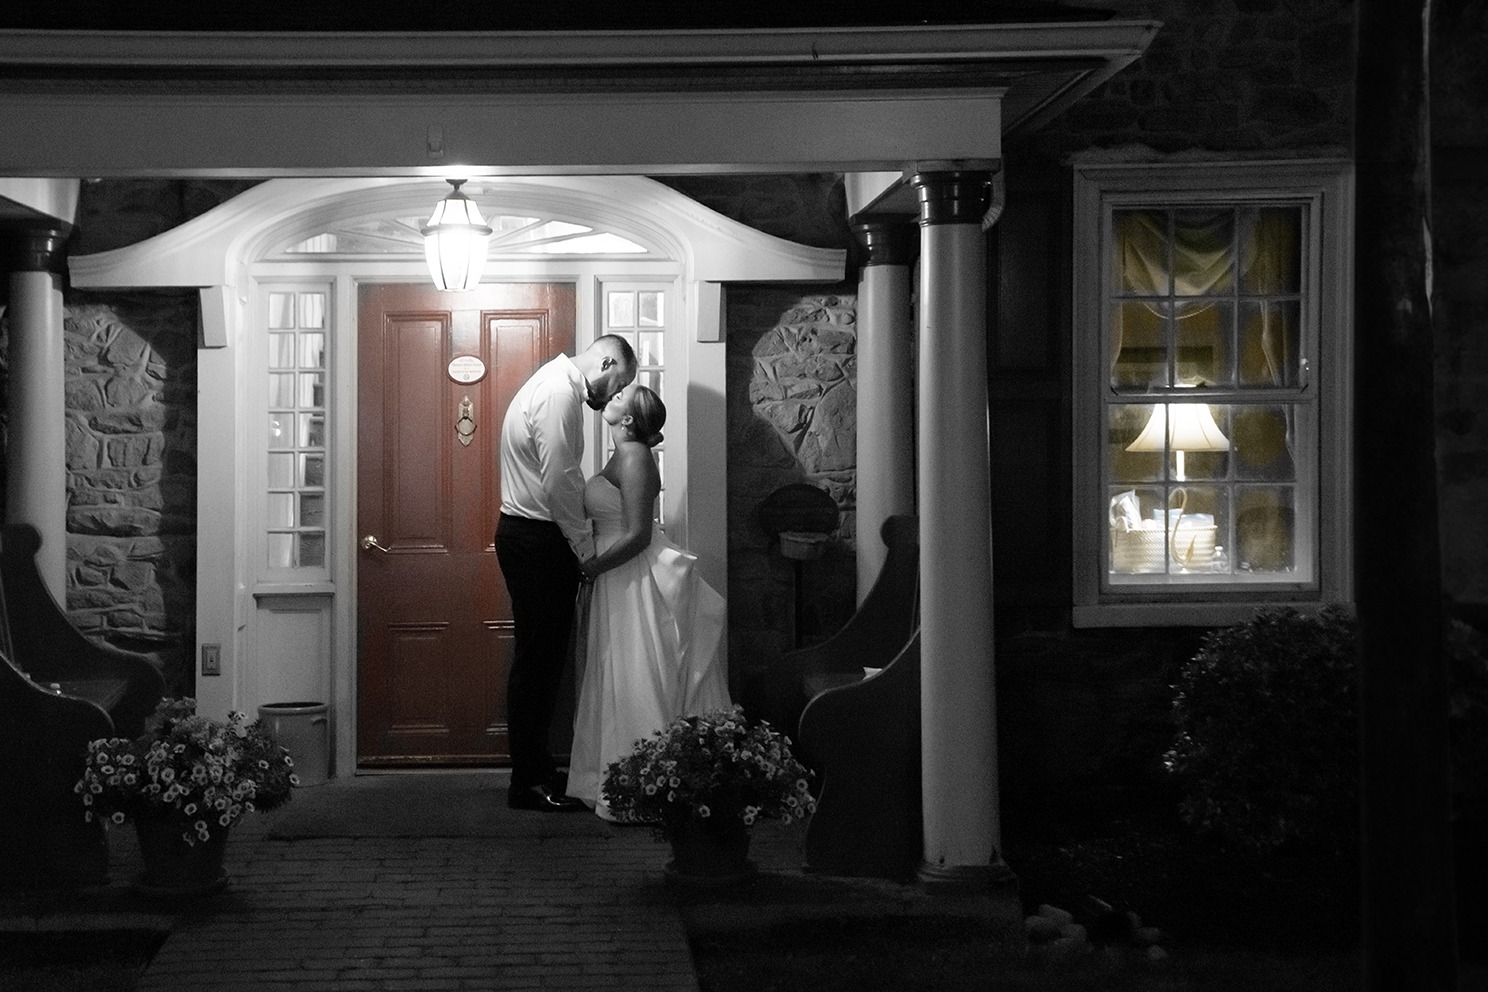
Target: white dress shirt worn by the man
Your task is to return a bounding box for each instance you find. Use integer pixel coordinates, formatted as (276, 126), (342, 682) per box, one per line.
(501, 355), (594, 561)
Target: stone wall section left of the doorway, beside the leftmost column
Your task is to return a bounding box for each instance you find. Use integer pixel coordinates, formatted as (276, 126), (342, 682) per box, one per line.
(64, 292), (196, 690)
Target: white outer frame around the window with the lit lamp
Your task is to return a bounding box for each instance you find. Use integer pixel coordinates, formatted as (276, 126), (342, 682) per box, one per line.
(1071, 159), (1353, 626)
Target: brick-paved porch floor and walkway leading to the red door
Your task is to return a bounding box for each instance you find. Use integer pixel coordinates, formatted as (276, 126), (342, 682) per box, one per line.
(0, 772), (1021, 992)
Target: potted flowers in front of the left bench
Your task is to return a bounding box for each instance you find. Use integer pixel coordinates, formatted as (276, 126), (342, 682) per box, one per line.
(74, 699), (298, 894)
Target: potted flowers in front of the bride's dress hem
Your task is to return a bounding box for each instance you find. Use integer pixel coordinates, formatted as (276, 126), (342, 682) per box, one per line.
(601, 706), (817, 880)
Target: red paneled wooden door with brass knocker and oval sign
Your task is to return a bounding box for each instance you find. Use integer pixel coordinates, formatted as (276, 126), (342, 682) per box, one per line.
(357, 283), (574, 766)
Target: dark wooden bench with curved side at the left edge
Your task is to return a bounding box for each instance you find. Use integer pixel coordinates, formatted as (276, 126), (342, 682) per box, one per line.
(0, 525), (165, 889)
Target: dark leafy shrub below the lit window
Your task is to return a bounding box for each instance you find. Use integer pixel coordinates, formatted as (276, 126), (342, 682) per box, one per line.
(1165, 607), (1359, 852)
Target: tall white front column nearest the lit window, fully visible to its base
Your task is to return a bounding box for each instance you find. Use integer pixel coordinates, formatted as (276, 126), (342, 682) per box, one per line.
(914, 173), (1012, 889)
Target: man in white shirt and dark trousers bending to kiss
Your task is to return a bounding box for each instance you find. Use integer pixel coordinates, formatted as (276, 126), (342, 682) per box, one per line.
(496, 335), (635, 812)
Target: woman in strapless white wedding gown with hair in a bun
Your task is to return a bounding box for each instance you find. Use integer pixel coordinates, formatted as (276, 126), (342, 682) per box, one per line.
(567, 384), (731, 819)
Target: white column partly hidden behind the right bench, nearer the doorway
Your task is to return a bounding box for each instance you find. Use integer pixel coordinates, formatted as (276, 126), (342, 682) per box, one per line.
(857, 220), (915, 604)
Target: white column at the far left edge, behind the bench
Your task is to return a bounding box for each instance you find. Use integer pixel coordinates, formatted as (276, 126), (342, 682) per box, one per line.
(6, 239), (67, 600)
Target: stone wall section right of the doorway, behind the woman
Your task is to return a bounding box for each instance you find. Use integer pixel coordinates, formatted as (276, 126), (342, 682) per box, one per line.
(661, 174), (857, 675)
